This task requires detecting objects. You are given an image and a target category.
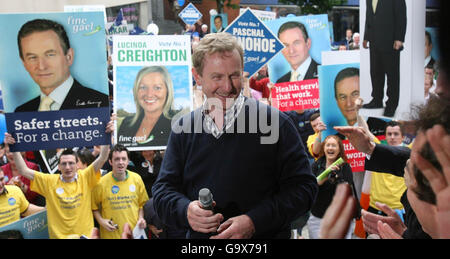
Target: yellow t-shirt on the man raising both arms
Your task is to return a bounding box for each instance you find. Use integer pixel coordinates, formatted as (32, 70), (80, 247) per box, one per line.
(30, 164), (101, 239)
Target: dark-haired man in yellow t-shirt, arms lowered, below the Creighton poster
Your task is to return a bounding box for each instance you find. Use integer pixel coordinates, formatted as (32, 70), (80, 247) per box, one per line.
(92, 144), (149, 239)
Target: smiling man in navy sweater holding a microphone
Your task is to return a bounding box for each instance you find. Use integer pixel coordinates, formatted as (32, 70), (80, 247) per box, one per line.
(152, 33), (318, 239)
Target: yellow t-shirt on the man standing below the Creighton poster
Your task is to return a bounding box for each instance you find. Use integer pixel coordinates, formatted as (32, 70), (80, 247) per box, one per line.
(92, 171), (149, 239)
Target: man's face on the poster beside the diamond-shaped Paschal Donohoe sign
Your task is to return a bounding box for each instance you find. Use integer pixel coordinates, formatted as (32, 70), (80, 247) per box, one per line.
(279, 27), (311, 70)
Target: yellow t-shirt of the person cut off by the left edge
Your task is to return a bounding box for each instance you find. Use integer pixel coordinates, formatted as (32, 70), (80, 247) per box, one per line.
(0, 185), (30, 227)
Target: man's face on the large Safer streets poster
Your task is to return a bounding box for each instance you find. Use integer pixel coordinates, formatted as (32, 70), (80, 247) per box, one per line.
(20, 30), (73, 95)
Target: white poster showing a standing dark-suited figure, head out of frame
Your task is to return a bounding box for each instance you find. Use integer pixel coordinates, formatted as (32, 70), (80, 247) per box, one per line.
(359, 0), (426, 120)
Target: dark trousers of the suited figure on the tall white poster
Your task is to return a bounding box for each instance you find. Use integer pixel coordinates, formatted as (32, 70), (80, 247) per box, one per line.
(370, 48), (400, 111)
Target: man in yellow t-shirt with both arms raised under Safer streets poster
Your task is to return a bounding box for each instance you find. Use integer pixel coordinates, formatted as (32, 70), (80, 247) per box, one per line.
(5, 119), (114, 239)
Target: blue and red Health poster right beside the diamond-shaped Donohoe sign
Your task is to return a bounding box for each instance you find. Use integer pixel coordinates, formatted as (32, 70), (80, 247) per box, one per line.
(266, 15), (330, 111)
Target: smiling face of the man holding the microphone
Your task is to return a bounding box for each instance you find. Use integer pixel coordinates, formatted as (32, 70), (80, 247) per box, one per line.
(192, 50), (243, 111)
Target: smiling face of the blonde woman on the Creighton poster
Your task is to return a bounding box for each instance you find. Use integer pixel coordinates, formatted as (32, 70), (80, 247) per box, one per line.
(137, 72), (167, 115)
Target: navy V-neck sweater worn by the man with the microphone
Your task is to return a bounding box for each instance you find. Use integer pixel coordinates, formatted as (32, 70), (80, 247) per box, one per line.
(152, 99), (318, 238)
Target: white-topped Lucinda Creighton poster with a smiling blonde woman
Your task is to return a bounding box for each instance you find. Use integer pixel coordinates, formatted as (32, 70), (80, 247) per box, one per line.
(113, 35), (192, 150)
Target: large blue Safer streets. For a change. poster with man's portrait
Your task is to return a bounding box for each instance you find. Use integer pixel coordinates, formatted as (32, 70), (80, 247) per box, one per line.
(0, 12), (111, 151)
